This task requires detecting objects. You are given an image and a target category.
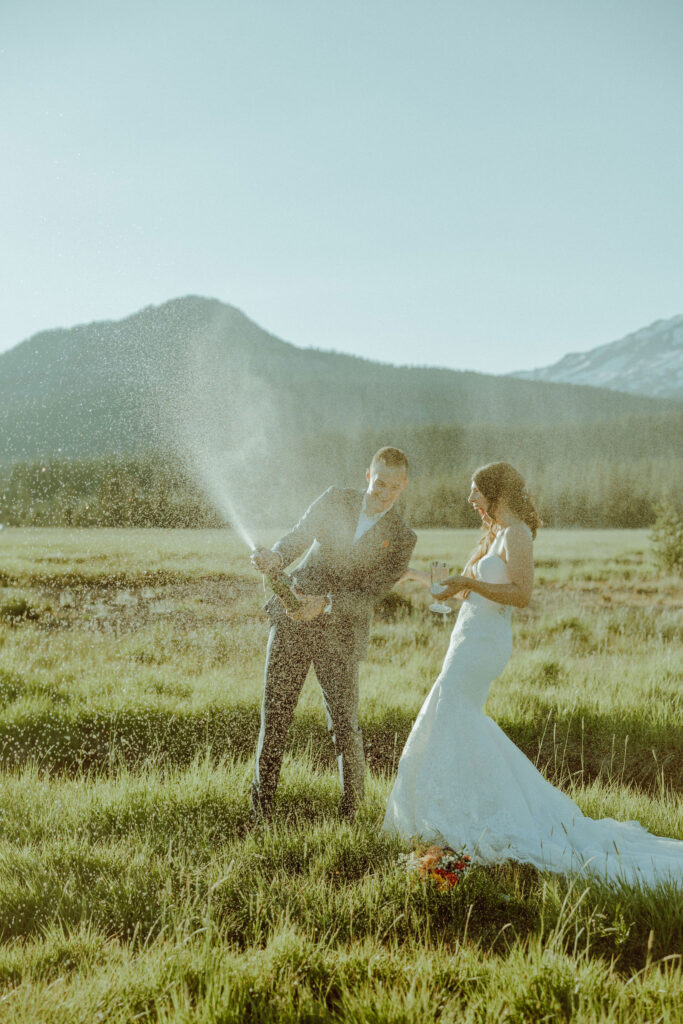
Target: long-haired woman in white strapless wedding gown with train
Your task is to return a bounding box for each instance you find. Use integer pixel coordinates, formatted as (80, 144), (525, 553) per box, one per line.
(383, 462), (683, 885)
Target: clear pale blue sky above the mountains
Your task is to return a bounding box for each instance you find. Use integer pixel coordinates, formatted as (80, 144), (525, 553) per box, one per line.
(0, 0), (683, 373)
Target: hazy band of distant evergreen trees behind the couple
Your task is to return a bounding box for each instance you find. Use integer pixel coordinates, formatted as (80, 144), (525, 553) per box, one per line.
(0, 415), (682, 528)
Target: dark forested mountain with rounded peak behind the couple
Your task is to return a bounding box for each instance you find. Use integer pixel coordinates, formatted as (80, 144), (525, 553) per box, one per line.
(0, 296), (666, 467)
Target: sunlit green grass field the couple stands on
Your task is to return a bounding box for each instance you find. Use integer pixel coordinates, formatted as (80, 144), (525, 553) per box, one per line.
(0, 529), (683, 1024)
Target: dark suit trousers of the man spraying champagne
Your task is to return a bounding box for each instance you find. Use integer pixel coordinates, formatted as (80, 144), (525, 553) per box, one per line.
(252, 617), (365, 817)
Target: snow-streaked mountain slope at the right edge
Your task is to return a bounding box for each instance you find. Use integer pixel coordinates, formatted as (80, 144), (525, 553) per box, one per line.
(512, 315), (683, 398)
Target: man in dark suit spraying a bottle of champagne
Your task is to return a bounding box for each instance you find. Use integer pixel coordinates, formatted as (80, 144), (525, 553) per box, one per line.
(251, 447), (417, 823)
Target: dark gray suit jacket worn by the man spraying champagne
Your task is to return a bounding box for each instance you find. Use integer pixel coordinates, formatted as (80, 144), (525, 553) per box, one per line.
(265, 487), (417, 659)
